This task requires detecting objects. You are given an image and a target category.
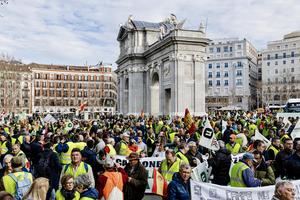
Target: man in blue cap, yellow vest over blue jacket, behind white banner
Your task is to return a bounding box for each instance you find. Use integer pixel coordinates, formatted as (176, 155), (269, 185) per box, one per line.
(230, 152), (261, 187)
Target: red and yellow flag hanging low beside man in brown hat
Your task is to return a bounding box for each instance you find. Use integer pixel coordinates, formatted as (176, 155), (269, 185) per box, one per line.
(152, 169), (168, 197)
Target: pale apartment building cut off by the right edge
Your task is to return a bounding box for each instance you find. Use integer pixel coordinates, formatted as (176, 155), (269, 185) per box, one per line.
(262, 31), (300, 105)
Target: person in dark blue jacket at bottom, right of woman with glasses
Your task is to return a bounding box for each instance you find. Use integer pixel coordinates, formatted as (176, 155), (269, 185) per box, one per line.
(75, 174), (99, 200)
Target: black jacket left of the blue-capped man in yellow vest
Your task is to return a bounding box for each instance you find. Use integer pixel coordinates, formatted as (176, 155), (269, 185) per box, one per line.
(208, 149), (231, 185)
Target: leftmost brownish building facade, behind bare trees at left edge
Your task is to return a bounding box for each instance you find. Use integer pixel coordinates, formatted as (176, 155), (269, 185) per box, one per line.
(0, 61), (32, 113)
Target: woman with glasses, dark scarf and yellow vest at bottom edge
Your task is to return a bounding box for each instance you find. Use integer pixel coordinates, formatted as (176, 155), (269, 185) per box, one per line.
(55, 175), (80, 200)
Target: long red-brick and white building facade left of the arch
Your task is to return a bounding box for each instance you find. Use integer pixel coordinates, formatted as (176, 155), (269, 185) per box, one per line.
(30, 64), (117, 113)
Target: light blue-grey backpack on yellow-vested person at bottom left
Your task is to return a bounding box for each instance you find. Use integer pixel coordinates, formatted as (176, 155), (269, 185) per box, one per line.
(8, 172), (32, 200)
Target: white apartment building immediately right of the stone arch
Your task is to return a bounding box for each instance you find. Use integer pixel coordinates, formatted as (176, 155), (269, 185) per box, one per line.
(206, 38), (258, 110)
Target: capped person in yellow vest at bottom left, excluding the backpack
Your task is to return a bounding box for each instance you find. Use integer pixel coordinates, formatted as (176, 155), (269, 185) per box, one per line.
(2, 156), (33, 197)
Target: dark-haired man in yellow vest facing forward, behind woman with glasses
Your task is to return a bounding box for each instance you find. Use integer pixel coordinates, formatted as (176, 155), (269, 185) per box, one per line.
(59, 148), (95, 188)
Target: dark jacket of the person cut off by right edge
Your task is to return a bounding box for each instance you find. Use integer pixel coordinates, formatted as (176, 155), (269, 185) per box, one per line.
(284, 152), (300, 180)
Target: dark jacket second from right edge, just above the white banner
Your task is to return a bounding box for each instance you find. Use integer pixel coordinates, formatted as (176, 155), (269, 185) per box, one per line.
(274, 149), (293, 178)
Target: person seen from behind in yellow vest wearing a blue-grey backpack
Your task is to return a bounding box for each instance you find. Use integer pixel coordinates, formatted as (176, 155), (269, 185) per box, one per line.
(3, 156), (32, 199)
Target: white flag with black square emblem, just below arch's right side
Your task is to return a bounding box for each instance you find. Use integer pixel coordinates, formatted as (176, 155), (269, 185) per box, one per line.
(199, 120), (220, 151)
